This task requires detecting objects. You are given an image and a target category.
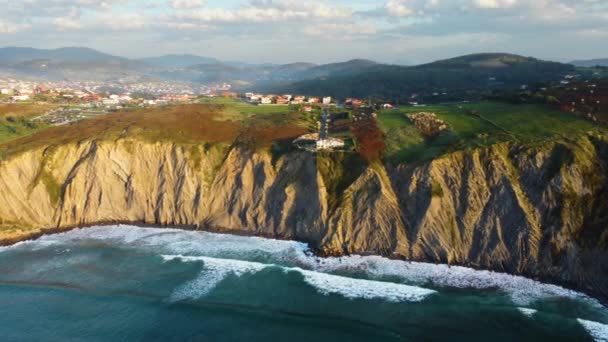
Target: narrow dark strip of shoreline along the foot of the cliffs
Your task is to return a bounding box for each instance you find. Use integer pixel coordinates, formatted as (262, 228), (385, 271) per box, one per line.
(0, 221), (608, 308)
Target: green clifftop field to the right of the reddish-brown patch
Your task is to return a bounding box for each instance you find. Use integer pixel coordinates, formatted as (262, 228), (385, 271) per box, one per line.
(379, 101), (598, 163)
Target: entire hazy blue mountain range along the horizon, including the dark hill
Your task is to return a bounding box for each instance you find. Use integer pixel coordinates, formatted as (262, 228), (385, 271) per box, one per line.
(0, 47), (588, 99)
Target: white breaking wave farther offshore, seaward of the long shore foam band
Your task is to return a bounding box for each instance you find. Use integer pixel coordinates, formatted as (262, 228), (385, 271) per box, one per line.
(162, 255), (436, 302)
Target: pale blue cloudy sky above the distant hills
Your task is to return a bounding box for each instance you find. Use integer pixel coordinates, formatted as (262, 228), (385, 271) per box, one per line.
(0, 0), (608, 64)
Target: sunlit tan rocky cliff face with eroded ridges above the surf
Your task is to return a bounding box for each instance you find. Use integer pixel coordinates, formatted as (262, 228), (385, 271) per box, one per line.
(0, 136), (608, 298)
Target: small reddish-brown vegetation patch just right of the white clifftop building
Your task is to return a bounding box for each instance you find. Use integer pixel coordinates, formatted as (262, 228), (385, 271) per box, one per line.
(351, 118), (386, 161)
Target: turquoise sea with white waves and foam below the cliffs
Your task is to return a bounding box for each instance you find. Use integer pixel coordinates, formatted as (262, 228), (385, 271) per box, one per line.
(0, 226), (608, 341)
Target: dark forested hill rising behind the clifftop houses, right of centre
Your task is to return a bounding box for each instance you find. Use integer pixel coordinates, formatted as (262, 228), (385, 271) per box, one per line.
(269, 53), (574, 101)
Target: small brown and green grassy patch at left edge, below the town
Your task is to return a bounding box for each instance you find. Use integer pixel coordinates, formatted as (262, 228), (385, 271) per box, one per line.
(0, 103), (54, 144)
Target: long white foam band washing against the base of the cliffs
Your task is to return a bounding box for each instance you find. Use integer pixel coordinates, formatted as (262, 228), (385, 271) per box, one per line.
(3, 225), (602, 307)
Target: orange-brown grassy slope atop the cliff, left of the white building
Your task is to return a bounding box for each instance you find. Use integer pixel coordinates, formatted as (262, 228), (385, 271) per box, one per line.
(0, 103), (308, 156)
